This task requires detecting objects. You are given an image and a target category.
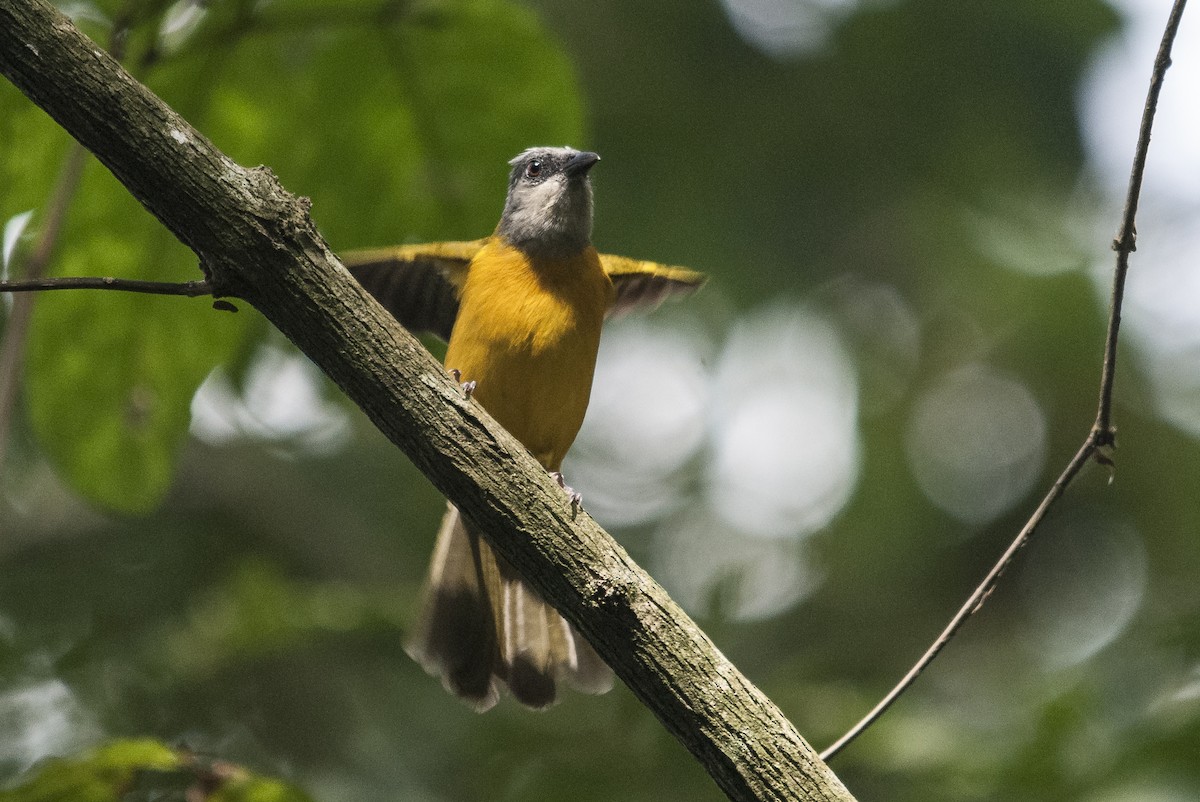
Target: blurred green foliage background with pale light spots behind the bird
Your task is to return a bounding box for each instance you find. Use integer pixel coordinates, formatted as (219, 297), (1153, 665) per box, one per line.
(0, 0), (1200, 802)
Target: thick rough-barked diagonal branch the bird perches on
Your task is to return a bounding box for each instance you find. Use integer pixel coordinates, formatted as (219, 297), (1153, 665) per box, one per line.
(0, 0), (852, 801)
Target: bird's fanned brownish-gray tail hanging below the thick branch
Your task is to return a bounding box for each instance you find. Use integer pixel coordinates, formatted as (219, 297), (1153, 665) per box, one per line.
(407, 504), (612, 712)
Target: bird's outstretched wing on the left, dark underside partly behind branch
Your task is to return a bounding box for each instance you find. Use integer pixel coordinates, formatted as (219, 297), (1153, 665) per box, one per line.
(342, 240), (485, 341)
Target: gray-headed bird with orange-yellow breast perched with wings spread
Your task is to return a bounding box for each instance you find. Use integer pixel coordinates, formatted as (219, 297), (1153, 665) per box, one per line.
(342, 146), (704, 712)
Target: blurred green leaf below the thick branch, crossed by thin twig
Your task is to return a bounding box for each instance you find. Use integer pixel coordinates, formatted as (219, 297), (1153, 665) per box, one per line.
(25, 163), (251, 514)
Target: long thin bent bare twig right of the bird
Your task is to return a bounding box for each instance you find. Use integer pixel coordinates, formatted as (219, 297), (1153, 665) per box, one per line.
(821, 0), (1187, 761)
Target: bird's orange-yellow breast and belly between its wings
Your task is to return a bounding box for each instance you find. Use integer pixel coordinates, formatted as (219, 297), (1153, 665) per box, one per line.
(445, 238), (613, 471)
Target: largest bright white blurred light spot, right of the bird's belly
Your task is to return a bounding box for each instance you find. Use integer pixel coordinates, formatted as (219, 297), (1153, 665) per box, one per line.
(708, 306), (860, 538)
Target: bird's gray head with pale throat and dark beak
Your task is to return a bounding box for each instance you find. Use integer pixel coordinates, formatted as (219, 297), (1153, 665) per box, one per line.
(496, 148), (600, 258)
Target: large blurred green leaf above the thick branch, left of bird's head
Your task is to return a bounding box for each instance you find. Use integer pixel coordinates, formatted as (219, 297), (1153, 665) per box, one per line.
(185, 0), (583, 247)
